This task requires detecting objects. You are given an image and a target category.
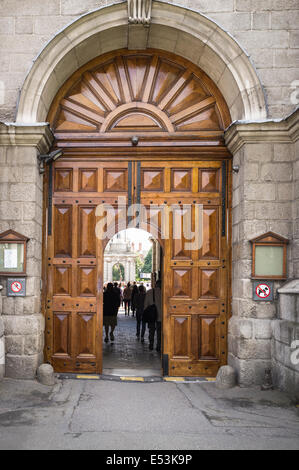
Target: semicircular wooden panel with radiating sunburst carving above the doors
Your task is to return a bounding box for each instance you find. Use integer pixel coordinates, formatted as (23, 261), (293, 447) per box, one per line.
(48, 50), (230, 140)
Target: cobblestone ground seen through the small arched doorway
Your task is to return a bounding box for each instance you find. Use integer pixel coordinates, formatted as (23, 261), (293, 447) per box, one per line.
(103, 309), (161, 375)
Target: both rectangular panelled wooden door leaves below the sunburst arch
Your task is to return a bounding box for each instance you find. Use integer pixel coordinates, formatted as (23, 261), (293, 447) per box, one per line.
(46, 156), (230, 376)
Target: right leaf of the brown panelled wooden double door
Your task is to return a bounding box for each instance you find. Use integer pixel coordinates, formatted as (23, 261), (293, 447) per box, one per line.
(141, 160), (228, 377)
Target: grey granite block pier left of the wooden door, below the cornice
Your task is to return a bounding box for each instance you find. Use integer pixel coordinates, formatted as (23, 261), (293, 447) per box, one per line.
(0, 131), (51, 379)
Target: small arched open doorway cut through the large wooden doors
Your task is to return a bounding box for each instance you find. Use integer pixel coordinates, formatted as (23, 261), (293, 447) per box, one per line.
(103, 228), (163, 376)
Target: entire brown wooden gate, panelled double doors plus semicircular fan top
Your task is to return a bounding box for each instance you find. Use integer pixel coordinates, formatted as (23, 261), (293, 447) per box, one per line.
(44, 49), (231, 376)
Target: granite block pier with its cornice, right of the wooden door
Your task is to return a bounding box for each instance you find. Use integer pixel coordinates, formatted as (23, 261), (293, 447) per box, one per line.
(227, 112), (299, 385)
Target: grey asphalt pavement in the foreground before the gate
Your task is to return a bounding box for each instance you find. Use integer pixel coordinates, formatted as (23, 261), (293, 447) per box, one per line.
(0, 379), (299, 451)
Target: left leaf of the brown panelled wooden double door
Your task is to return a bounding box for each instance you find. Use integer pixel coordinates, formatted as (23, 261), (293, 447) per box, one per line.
(45, 159), (128, 373)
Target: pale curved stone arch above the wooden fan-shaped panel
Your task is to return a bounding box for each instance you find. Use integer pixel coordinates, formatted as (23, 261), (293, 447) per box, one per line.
(17, 1), (267, 123)
